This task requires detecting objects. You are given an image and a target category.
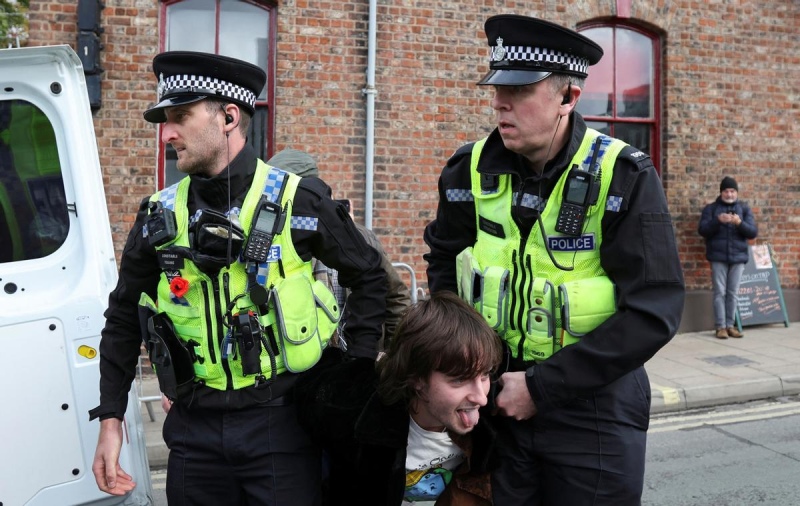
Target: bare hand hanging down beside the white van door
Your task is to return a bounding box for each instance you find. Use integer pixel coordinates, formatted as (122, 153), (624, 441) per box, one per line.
(92, 418), (136, 495)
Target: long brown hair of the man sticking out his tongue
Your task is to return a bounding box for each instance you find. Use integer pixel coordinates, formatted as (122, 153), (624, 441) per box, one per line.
(377, 292), (502, 405)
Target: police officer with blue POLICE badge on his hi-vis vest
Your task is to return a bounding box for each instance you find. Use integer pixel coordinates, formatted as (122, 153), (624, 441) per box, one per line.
(425, 15), (684, 506)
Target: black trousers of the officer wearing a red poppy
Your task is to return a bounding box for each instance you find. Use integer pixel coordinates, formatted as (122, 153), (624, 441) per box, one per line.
(163, 402), (321, 506)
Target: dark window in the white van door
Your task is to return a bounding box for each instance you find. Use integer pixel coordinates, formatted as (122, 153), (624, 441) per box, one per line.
(0, 100), (69, 263)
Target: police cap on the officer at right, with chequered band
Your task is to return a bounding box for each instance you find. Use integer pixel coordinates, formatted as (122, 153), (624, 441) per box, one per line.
(478, 14), (603, 86)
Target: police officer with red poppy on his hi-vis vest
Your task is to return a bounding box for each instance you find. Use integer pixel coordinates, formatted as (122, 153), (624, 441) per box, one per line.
(90, 51), (386, 505)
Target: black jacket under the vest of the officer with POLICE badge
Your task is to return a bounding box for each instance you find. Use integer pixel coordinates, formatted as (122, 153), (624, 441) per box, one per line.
(425, 113), (685, 414)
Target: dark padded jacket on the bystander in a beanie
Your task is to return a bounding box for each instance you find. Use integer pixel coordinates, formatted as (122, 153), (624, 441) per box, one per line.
(697, 197), (758, 264)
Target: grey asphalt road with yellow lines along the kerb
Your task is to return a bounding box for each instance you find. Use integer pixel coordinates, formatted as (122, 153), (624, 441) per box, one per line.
(150, 396), (800, 506)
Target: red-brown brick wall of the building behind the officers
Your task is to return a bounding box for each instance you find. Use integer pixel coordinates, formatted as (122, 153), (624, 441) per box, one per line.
(25, 0), (800, 289)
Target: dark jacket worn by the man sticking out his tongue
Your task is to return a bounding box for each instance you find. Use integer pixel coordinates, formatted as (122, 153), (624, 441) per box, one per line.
(294, 349), (495, 506)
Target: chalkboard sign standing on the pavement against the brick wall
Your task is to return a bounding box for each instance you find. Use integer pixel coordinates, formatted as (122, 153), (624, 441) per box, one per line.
(736, 244), (789, 328)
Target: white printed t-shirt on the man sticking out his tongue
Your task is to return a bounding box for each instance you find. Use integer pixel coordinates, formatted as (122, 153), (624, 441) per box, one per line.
(403, 417), (464, 506)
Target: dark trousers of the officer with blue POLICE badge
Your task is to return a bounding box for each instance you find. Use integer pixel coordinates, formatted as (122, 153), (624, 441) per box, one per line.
(492, 368), (650, 506)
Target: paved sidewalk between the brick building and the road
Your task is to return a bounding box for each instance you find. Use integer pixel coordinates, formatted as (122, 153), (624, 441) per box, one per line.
(136, 323), (800, 468)
